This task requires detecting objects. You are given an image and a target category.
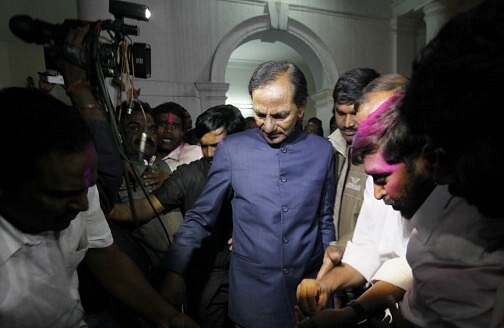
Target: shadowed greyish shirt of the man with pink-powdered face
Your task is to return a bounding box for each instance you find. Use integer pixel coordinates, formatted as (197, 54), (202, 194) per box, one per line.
(401, 186), (504, 328)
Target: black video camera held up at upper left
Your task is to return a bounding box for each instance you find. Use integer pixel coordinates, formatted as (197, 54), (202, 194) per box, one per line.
(9, 0), (151, 78)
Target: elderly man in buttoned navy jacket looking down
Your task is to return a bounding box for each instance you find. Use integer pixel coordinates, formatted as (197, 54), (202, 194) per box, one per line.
(162, 61), (335, 328)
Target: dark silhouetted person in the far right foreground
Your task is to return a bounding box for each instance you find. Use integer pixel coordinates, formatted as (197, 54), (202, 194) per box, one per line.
(401, 0), (504, 327)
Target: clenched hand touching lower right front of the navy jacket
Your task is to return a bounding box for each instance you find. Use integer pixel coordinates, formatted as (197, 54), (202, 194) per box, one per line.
(296, 279), (331, 316)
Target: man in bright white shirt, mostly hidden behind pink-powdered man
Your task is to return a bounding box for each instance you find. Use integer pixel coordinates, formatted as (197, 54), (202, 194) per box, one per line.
(297, 74), (413, 328)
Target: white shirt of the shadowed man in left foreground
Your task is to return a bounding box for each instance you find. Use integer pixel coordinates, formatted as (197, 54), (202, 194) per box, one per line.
(0, 186), (112, 328)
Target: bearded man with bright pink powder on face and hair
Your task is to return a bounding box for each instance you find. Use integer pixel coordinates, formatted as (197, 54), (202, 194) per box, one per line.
(352, 91), (504, 327)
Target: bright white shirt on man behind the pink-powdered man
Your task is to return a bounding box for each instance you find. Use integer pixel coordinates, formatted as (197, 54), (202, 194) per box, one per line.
(342, 176), (413, 289)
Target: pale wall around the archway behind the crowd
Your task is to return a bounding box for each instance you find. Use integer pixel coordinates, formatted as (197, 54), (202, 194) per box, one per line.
(0, 0), (474, 127)
